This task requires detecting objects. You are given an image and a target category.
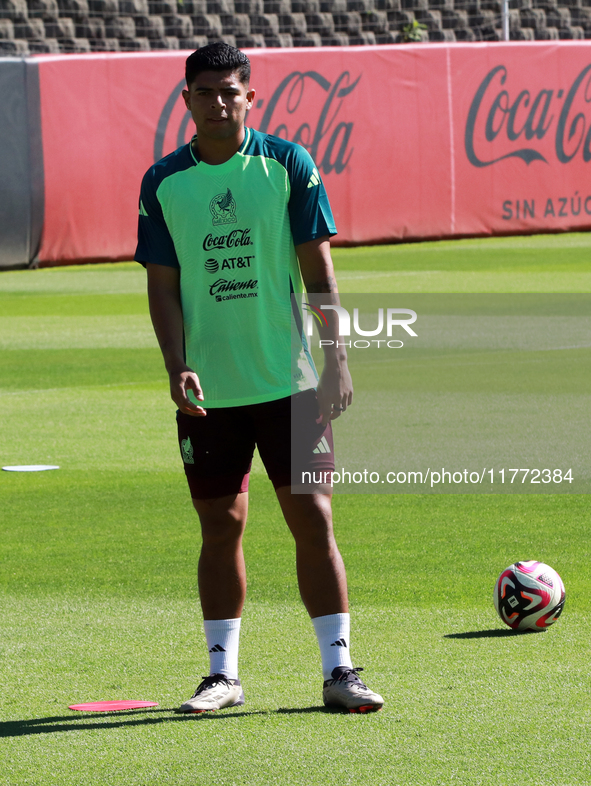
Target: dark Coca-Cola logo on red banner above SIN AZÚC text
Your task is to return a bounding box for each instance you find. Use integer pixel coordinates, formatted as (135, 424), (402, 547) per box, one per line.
(464, 65), (591, 167)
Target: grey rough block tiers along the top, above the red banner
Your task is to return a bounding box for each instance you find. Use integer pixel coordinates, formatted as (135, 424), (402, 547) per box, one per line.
(0, 0), (591, 50)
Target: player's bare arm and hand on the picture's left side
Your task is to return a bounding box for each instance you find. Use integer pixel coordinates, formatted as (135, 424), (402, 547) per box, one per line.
(146, 262), (207, 417)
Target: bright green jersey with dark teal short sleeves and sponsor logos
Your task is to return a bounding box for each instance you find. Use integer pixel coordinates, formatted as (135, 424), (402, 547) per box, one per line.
(135, 128), (336, 407)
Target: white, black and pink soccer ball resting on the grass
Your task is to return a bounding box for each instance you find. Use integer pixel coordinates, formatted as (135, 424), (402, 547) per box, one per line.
(493, 560), (565, 630)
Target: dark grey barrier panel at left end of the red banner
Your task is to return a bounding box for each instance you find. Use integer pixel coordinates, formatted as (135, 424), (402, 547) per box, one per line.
(0, 58), (43, 268)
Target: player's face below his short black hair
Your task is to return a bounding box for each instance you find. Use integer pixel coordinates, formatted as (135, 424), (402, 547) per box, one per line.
(183, 71), (254, 140)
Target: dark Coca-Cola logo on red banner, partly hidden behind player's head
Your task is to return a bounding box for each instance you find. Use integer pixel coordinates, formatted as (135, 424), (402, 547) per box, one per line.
(154, 71), (361, 175)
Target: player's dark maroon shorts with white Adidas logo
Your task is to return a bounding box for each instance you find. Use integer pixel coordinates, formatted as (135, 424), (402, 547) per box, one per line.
(177, 390), (334, 499)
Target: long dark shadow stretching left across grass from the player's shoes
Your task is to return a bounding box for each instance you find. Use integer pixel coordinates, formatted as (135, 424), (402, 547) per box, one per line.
(0, 706), (332, 738)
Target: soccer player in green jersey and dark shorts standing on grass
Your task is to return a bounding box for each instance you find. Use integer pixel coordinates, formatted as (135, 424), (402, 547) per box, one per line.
(135, 43), (383, 712)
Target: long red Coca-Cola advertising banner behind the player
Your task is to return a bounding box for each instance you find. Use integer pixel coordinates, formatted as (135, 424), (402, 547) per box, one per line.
(36, 41), (591, 263)
